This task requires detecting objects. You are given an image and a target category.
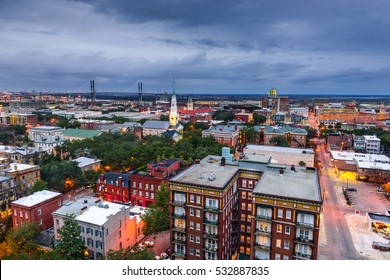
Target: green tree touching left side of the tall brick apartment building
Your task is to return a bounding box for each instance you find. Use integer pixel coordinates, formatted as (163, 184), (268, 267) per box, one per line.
(142, 182), (170, 235)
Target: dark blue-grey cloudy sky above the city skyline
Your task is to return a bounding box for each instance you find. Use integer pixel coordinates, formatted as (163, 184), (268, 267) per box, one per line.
(0, 0), (390, 95)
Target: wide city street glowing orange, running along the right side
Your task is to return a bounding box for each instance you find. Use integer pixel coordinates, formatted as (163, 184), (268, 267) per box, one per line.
(318, 139), (390, 260)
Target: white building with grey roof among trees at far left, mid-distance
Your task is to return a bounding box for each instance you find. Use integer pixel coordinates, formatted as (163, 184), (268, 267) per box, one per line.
(28, 126), (65, 153)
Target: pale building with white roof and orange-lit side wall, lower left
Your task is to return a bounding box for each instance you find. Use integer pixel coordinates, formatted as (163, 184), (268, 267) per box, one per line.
(53, 197), (144, 259)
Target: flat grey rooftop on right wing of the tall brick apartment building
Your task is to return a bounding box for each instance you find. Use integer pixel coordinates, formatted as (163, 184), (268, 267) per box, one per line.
(253, 167), (322, 203)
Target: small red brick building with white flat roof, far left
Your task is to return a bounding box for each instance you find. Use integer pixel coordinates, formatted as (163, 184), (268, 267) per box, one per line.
(11, 190), (63, 231)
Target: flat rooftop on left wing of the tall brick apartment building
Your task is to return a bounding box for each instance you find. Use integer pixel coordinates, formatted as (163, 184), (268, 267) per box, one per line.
(170, 155), (239, 188)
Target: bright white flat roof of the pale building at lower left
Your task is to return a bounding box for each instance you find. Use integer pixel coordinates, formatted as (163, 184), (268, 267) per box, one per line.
(76, 201), (130, 226)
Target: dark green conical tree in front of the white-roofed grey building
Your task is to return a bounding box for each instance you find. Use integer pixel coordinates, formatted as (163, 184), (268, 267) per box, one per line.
(55, 215), (86, 260)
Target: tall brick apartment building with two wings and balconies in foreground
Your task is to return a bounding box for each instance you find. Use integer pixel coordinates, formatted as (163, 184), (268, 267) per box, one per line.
(170, 156), (322, 260)
